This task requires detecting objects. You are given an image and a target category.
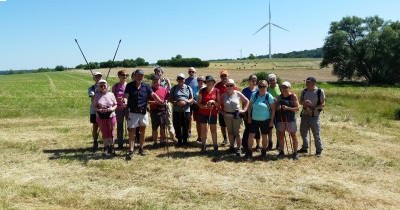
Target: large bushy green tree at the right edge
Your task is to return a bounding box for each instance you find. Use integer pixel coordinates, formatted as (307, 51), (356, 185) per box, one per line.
(320, 16), (400, 84)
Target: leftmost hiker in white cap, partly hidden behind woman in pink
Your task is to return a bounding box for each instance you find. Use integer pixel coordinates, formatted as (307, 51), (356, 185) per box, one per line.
(88, 72), (103, 152)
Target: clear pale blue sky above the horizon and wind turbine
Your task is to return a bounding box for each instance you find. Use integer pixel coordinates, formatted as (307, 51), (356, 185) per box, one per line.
(0, 0), (400, 70)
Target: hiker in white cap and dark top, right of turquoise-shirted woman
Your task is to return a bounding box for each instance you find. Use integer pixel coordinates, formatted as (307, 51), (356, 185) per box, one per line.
(276, 81), (299, 160)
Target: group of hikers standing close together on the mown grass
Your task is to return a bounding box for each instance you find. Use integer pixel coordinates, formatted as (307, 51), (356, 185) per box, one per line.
(88, 67), (325, 160)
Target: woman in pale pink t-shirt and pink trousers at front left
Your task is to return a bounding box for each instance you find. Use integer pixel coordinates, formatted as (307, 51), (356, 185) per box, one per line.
(93, 80), (117, 155)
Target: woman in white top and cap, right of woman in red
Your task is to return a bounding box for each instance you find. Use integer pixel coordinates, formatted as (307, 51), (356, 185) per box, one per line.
(219, 79), (249, 156)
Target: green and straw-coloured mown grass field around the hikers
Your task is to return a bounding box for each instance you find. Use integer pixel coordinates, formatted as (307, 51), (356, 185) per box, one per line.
(0, 62), (400, 209)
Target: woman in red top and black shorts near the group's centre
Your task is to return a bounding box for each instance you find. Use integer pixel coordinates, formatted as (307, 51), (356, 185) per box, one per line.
(197, 75), (220, 154)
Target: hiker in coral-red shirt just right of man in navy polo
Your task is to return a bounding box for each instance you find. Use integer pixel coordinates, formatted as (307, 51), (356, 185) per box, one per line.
(149, 74), (169, 146)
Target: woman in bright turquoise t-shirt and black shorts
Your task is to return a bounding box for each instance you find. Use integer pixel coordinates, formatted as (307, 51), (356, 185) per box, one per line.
(245, 80), (275, 158)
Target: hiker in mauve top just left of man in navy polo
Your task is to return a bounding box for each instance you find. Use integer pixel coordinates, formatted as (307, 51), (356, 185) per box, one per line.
(111, 70), (129, 149)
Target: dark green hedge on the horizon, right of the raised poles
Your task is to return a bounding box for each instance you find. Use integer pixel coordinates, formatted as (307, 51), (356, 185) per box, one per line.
(157, 55), (210, 68)
